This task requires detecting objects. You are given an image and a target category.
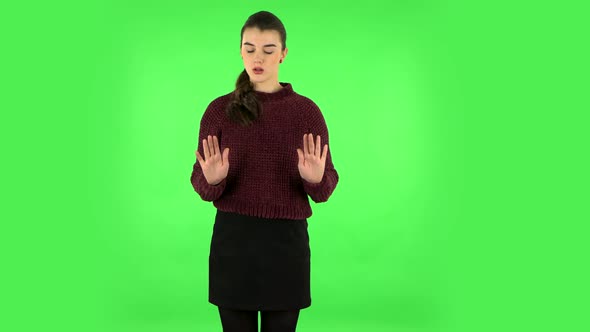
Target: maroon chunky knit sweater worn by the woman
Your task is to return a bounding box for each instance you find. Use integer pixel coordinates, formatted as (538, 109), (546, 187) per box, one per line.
(191, 82), (338, 219)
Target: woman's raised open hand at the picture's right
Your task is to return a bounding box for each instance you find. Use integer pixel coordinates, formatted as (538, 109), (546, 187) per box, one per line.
(297, 134), (328, 183)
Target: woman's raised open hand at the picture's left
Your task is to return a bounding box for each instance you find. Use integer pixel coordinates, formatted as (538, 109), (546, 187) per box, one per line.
(195, 135), (229, 185)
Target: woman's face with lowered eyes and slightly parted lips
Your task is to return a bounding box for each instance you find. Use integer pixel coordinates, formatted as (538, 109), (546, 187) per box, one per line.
(240, 28), (287, 85)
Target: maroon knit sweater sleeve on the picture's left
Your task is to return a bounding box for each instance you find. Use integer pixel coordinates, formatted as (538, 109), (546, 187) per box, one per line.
(191, 102), (226, 202)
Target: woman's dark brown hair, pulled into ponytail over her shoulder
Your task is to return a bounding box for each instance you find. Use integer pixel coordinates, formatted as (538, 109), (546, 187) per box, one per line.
(226, 11), (287, 126)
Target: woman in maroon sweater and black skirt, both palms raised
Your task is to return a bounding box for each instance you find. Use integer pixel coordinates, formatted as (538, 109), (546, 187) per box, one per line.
(191, 11), (338, 332)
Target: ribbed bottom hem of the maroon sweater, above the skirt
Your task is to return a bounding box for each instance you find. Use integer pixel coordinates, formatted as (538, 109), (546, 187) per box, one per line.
(213, 201), (312, 219)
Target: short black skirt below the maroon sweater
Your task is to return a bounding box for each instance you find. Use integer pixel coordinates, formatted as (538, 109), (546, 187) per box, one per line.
(209, 209), (311, 310)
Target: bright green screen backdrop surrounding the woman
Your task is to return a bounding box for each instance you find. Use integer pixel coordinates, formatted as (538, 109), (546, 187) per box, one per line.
(0, 0), (590, 332)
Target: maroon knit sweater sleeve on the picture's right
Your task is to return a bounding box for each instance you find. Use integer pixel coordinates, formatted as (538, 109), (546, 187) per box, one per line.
(301, 104), (339, 203)
